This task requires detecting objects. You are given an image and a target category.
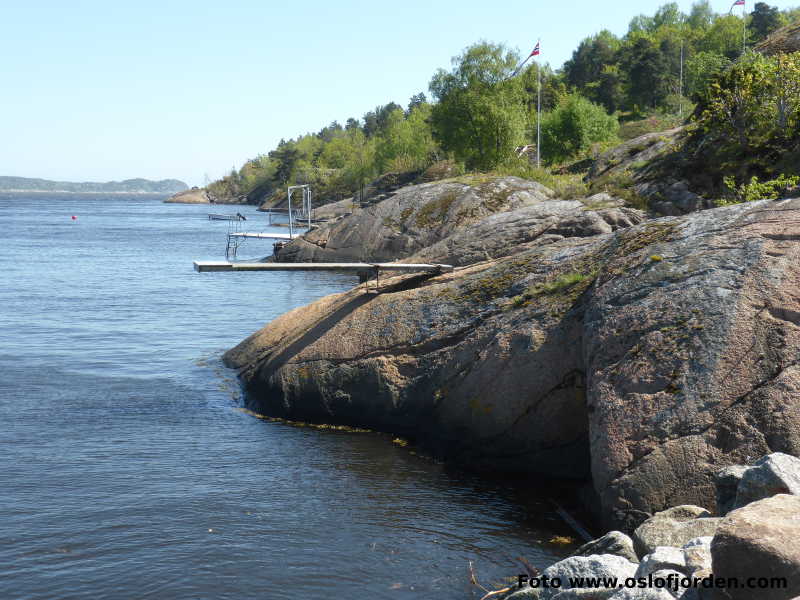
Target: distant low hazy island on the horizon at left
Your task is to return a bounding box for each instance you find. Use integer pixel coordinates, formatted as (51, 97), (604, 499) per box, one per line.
(0, 176), (189, 194)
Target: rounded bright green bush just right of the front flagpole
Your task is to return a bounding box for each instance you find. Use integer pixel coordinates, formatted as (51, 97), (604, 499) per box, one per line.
(542, 94), (619, 162)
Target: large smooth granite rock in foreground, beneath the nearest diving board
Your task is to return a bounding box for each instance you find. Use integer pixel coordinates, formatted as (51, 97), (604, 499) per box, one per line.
(225, 197), (800, 524)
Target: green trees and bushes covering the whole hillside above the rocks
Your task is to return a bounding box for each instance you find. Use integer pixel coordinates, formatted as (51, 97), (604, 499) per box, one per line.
(202, 0), (800, 210)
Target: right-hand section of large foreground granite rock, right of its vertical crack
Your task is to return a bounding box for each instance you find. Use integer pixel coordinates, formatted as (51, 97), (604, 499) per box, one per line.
(583, 199), (800, 537)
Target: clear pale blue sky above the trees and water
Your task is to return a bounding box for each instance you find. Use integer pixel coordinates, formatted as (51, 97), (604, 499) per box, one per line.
(0, 0), (797, 185)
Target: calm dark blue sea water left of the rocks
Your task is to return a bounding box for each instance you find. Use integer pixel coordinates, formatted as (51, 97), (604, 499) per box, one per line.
(0, 194), (576, 600)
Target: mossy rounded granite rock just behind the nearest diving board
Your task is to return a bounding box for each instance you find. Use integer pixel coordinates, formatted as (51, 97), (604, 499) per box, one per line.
(277, 177), (645, 265)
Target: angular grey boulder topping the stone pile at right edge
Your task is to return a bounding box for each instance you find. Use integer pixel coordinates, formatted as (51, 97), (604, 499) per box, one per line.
(734, 452), (800, 508)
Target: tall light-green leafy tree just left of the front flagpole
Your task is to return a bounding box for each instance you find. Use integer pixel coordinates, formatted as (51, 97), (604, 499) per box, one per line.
(430, 42), (526, 170)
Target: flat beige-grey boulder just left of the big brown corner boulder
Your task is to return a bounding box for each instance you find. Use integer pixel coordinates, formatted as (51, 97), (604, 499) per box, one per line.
(633, 506), (719, 556)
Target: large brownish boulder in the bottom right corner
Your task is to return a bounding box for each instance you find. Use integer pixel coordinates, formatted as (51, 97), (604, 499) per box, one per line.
(711, 494), (800, 600)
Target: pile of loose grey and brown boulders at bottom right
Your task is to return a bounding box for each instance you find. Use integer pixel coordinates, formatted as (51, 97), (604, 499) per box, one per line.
(506, 453), (800, 600)
